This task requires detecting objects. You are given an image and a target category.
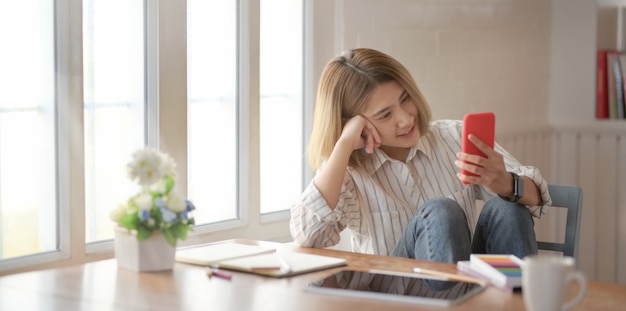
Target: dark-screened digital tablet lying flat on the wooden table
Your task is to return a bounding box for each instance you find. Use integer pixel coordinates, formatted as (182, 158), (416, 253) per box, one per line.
(305, 270), (485, 306)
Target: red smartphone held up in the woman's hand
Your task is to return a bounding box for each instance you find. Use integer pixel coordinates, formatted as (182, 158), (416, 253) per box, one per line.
(461, 112), (496, 184)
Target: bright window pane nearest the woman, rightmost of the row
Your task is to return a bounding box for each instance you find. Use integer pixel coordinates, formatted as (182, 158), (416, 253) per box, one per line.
(260, 0), (304, 213)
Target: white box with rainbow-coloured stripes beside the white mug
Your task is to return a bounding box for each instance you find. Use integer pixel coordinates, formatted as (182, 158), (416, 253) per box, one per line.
(457, 254), (523, 290)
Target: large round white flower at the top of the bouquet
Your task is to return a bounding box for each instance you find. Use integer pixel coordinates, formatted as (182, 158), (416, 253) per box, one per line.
(127, 148), (163, 186)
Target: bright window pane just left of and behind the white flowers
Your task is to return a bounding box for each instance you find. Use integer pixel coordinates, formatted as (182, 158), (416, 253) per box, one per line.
(83, 0), (146, 243)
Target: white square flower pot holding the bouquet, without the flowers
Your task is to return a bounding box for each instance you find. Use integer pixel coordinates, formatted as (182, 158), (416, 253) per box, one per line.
(115, 227), (176, 272)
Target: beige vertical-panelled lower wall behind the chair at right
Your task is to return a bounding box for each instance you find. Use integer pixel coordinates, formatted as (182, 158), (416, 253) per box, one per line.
(496, 129), (626, 284)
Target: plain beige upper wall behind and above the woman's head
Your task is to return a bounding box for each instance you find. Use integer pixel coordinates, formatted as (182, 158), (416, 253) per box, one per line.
(316, 0), (551, 133)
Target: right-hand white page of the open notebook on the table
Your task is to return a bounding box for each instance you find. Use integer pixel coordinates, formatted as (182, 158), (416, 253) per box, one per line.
(215, 252), (346, 277)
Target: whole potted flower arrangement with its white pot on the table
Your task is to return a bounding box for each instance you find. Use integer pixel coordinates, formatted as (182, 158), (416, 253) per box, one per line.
(110, 148), (195, 271)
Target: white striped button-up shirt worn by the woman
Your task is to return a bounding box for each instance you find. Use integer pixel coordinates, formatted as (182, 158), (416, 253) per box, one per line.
(290, 120), (552, 255)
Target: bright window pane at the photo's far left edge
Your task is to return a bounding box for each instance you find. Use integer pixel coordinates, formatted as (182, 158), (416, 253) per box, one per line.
(0, 0), (58, 258)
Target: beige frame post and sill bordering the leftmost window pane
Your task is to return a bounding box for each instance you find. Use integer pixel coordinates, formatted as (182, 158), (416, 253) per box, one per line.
(0, 0), (85, 274)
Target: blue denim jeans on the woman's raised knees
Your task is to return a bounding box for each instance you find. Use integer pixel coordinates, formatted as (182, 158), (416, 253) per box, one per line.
(391, 196), (537, 263)
